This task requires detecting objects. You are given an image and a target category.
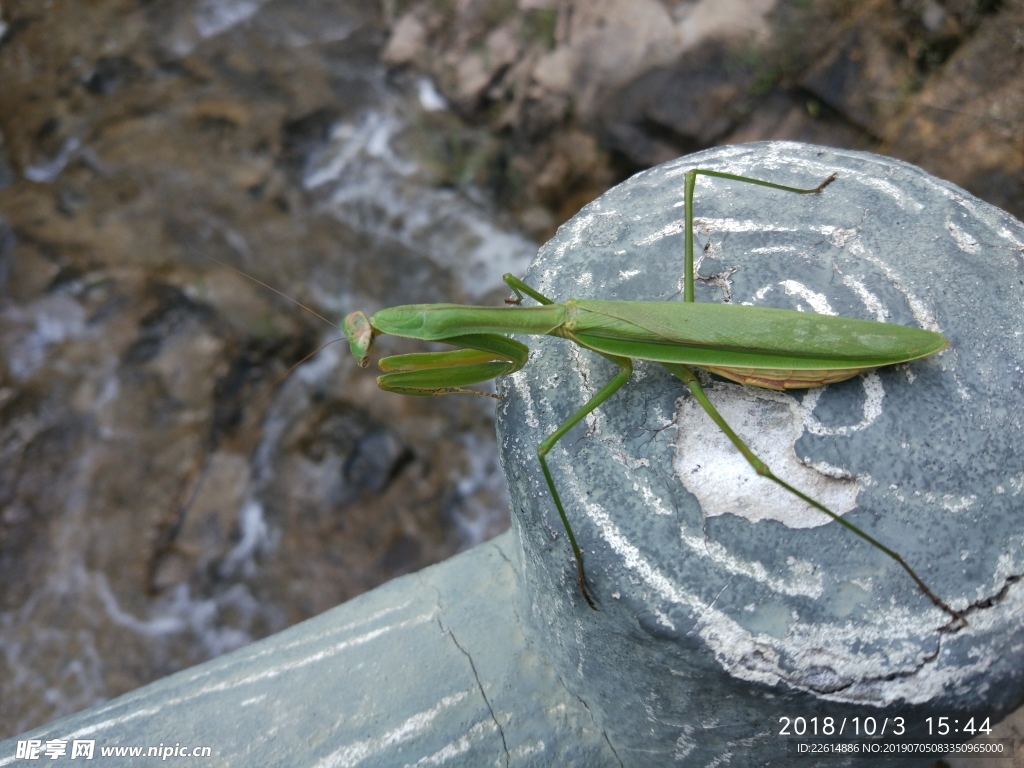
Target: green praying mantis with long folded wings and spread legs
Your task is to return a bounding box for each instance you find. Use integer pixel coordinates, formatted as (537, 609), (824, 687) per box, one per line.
(220, 169), (967, 628)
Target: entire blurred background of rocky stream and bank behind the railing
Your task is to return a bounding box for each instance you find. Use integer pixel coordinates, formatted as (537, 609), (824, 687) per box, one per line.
(0, 0), (1024, 738)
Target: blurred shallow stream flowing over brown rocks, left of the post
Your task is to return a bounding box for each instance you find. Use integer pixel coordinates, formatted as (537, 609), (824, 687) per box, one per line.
(0, 0), (512, 736)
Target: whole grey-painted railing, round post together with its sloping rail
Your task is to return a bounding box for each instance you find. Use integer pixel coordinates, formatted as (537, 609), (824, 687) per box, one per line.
(0, 143), (1024, 766)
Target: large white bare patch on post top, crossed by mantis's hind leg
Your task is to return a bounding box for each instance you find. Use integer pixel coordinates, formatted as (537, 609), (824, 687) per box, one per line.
(673, 384), (859, 528)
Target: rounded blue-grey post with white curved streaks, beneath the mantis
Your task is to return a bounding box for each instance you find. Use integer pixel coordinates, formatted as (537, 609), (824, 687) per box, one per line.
(499, 142), (1024, 765)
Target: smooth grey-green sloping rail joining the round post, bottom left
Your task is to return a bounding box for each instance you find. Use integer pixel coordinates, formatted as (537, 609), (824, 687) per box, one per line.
(0, 534), (623, 768)
